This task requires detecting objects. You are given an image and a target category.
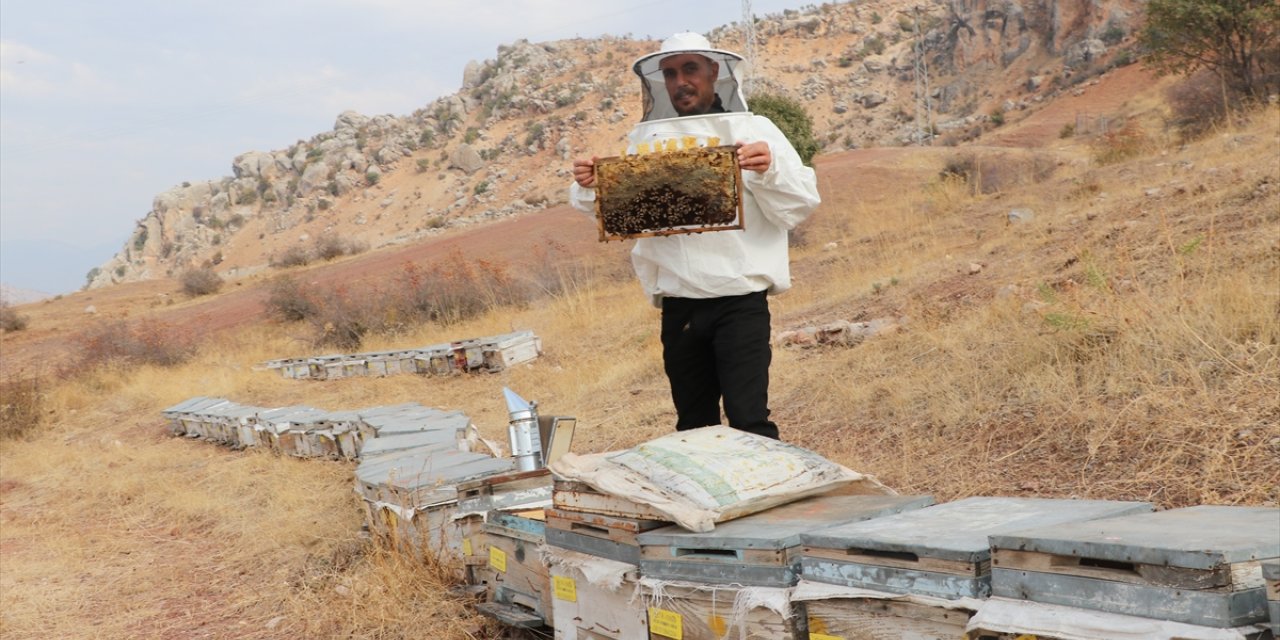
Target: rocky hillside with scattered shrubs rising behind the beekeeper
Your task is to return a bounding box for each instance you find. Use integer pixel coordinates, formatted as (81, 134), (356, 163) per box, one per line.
(88, 0), (1140, 288)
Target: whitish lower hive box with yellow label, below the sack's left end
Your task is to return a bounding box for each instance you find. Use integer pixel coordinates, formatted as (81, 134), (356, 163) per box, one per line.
(547, 545), (649, 640)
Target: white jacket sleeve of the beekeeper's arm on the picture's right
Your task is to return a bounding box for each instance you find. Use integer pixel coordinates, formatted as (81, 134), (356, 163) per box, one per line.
(742, 115), (822, 229)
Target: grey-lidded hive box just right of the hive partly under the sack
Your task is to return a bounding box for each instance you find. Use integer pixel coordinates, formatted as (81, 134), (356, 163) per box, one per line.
(800, 498), (1153, 599)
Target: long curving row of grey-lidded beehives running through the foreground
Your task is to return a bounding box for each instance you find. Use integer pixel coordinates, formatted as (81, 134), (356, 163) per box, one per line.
(164, 397), (1280, 640)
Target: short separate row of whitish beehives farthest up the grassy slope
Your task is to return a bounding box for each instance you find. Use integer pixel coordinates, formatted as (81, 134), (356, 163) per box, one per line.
(261, 330), (543, 380)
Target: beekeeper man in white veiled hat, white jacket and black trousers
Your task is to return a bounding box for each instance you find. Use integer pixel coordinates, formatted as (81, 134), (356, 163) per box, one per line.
(570, 33), (819, 438)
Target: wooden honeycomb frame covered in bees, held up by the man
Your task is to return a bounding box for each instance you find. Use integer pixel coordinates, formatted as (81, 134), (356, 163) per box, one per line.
(595, 140), (742, 242)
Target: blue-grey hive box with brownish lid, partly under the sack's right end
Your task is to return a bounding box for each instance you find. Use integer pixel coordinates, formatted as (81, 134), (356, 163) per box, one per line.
(636, 495), (933, 588)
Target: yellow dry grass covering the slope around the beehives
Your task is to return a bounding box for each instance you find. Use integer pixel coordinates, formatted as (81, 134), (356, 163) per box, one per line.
(0, 108), (1280, 639)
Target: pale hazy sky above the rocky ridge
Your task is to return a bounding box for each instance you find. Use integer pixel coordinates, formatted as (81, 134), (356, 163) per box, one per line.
(0, 0), (808, 293)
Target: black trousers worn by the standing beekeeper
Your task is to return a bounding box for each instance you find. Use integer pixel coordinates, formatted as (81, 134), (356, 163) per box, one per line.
(662, 292), (778, 439)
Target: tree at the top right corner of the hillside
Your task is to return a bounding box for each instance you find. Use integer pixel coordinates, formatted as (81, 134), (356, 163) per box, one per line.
(1138, 0), (1280, 96)
